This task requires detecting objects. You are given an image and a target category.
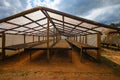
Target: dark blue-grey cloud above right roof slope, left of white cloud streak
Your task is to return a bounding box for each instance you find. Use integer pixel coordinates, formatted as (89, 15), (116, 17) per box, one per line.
(59, 0), (120, 16)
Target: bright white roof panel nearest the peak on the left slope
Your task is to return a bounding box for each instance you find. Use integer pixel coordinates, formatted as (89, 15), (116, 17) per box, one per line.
(26, 10), (45, 21)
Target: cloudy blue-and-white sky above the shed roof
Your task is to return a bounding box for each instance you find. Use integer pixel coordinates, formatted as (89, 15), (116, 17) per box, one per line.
(0, 0), (120, 24)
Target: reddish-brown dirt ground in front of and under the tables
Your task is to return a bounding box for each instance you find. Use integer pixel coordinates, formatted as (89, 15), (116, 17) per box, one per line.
(0, 50), (120, 80)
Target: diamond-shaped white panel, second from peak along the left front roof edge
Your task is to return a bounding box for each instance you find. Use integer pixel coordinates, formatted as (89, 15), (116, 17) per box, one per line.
(8, 16), (31, 25)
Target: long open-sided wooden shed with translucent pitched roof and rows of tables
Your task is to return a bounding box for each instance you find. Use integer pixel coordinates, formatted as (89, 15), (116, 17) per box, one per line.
(0, 6), (119, 60)
